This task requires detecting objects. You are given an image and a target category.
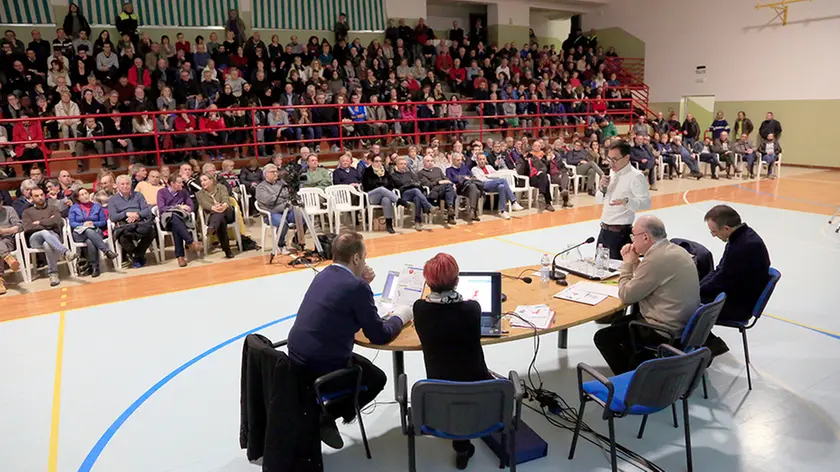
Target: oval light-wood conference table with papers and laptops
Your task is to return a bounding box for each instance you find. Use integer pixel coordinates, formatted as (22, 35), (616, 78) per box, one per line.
(356, 266), (625, 394)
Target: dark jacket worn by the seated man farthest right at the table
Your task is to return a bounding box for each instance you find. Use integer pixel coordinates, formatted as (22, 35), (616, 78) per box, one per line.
(700, 224), (770, 321)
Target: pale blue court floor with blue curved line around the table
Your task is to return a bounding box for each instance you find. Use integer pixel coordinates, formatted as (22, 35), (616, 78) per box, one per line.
(0, 202), (840, 472)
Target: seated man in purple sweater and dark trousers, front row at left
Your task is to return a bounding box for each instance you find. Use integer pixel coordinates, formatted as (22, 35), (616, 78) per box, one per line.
(157, 174), (201, 267)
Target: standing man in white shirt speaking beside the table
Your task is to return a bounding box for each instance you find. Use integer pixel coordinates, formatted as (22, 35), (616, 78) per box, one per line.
(595, 141), (650, 259)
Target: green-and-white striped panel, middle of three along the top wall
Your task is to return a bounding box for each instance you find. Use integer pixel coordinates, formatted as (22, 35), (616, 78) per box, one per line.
(80, 0), (239, 26)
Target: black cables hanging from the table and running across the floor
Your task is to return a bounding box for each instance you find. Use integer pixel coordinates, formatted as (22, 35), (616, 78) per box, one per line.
(505, 312), (665, 472)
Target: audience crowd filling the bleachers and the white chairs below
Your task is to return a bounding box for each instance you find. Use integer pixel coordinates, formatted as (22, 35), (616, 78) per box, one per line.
(0, 3), (781, 292)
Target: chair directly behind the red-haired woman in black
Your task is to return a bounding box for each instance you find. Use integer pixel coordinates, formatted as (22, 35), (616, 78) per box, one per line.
(397, 371), (523, 472)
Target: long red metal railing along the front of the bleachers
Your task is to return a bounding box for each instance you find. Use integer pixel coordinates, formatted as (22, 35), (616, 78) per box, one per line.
(0, 96), (638, 175)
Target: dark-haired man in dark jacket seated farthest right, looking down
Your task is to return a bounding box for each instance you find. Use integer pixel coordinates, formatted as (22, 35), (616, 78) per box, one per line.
(700, 205), (770, 356)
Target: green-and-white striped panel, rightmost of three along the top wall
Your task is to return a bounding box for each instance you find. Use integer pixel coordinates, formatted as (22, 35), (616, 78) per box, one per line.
(252, 0), (386, 31)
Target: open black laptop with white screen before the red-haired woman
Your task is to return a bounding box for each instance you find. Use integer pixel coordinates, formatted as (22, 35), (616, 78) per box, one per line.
(458, 272), (502, 337)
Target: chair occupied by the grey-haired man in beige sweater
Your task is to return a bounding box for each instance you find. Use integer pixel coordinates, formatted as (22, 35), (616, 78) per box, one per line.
(630, 293), (726, 398)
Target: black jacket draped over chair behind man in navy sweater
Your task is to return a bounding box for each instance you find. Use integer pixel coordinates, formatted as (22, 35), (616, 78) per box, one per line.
(239, 334), (324, 472)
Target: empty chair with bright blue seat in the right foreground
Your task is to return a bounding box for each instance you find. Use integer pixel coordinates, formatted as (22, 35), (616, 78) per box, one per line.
(569, 344), (712, 472)
